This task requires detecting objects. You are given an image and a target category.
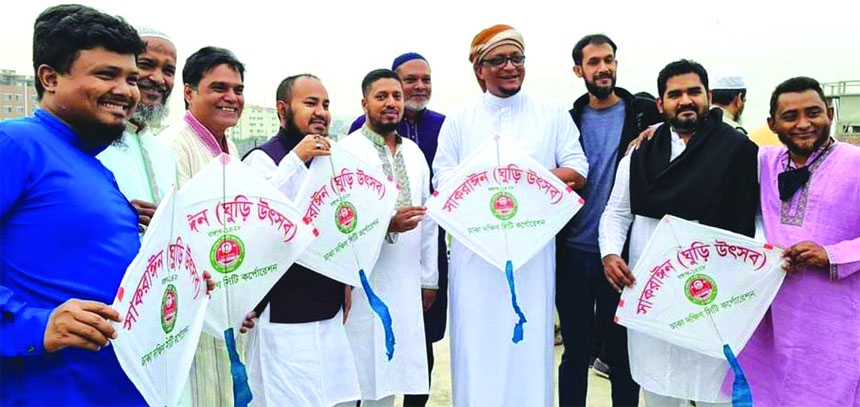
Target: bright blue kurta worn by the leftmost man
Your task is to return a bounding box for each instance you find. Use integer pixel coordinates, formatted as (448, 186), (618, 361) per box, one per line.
(0, 110), (145, 406)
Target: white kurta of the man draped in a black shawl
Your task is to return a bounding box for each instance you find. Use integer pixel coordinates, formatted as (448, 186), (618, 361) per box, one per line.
(598, 131), (731, 402)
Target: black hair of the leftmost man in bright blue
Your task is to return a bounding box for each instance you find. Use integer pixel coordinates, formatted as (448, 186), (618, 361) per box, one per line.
(33, 4), (146, 100)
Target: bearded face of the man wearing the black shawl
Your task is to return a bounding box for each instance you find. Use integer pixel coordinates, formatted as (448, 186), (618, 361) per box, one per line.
(657, 73), (710, 135)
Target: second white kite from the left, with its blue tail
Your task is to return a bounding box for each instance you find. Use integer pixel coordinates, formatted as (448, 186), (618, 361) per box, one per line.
(179, 154), (317, 405)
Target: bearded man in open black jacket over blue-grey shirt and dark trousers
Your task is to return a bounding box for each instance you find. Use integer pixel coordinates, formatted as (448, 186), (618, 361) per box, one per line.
(555, 34), (662, 406)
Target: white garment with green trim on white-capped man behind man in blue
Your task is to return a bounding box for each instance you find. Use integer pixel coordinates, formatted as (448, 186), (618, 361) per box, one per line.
(96, 128), (176, 204)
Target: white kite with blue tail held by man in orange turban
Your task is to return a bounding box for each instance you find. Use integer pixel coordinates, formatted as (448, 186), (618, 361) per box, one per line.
(425, 137), (585, 342)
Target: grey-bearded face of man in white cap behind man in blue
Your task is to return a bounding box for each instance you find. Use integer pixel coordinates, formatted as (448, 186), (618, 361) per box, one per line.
(134, 37), (176, 125)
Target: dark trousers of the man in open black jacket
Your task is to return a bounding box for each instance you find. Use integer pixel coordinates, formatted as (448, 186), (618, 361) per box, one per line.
(555, 244), (639, 407)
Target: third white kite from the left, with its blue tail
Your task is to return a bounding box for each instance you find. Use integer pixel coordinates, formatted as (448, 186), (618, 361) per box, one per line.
(296, 143), (398, 360)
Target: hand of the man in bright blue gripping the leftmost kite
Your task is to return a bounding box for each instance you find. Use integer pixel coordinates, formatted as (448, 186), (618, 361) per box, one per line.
(43, 299), (121, 353)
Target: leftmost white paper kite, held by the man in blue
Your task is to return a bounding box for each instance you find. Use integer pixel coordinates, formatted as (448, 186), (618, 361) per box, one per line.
(112, 189), (209, 406)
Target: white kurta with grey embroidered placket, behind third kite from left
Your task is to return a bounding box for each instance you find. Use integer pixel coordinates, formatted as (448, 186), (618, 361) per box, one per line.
(339, 130), (439, 400)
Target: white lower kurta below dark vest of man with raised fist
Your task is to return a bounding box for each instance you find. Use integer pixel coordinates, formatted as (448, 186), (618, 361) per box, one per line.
(245, 307), (361, 406)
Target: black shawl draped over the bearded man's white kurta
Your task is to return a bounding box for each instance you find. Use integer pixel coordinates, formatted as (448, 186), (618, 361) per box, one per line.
(630, 110), (759, 236)
